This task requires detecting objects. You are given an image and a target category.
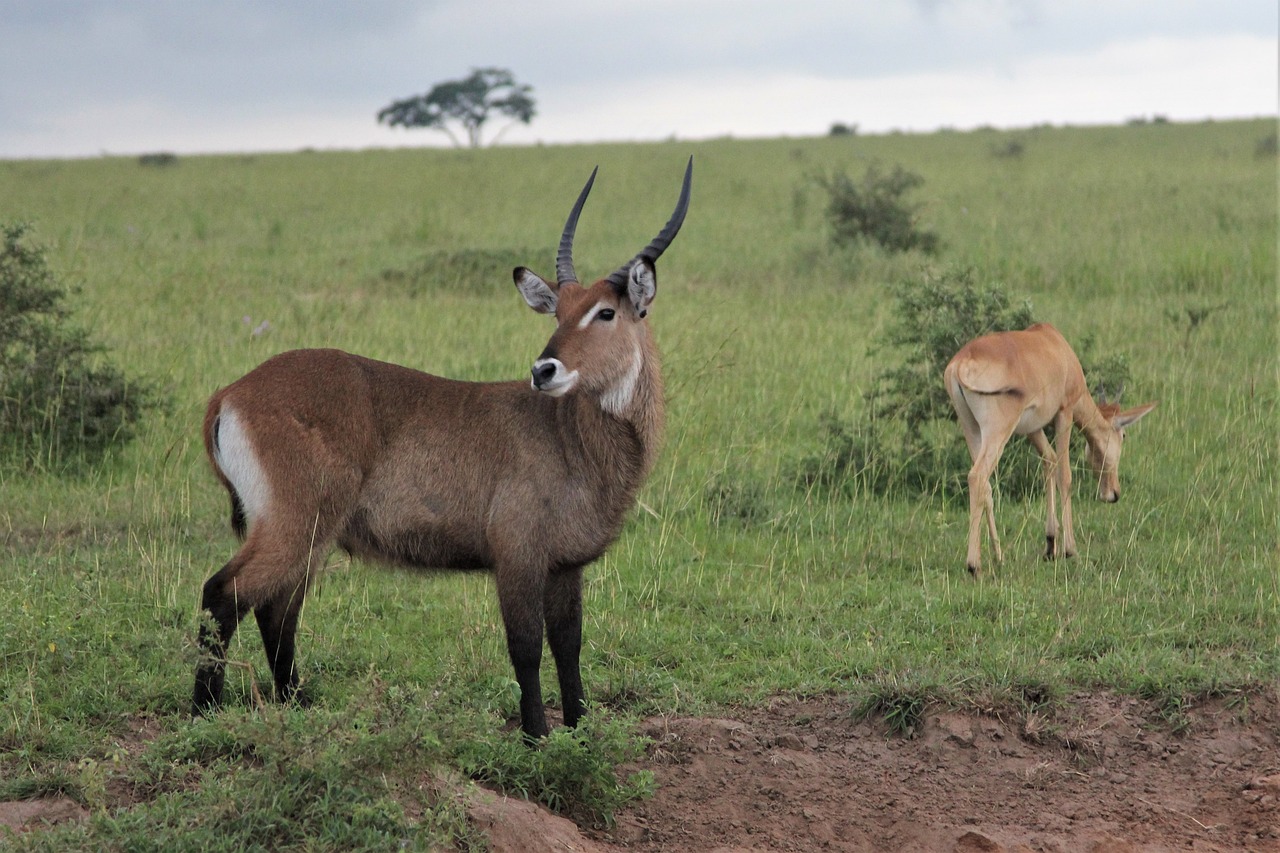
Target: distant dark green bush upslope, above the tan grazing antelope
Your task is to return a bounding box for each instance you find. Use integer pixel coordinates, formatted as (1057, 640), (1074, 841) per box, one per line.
(815, 164), (938, 254)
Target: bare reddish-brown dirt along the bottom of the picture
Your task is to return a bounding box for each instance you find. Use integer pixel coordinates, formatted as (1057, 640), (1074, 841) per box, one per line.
(0, 689), (1280, 853)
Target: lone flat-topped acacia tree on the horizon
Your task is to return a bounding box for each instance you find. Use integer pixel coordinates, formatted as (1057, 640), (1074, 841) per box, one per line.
(378, 68), (534, 149)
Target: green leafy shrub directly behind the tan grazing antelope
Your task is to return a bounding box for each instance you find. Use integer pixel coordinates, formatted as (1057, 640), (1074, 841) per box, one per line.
(799, 270), (1129, 498)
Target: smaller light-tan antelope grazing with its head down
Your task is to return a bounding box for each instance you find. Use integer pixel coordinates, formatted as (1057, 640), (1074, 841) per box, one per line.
(945, 323), (1156, 575)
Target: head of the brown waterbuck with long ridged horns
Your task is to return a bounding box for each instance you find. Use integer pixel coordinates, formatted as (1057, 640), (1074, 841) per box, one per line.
(513, 158), (694, 415)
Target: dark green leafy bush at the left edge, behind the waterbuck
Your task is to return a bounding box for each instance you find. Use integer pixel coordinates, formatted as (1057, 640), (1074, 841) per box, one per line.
(0, 224), (161, 469)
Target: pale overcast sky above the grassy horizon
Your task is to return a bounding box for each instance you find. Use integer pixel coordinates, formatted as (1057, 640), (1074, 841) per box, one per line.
(0, 0), (1280, 159)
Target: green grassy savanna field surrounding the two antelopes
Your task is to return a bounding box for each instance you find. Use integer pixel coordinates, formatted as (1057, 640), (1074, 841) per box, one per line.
(0, 119), (1280, 849)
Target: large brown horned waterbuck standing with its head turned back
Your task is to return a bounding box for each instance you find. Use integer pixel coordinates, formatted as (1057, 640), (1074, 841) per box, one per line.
(193, 158), (694, 738)
